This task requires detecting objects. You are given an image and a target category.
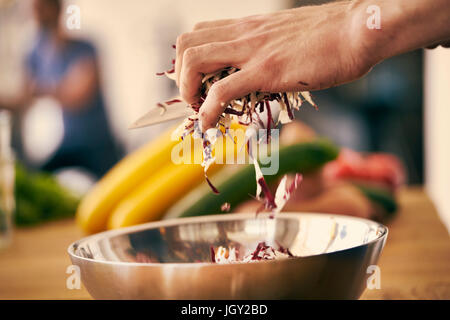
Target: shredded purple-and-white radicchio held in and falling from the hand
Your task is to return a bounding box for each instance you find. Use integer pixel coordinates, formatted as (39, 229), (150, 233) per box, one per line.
(157, 46), (317, 208)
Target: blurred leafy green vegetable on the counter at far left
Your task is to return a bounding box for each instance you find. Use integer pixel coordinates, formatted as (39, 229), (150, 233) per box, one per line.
(14, 164), (79, 226)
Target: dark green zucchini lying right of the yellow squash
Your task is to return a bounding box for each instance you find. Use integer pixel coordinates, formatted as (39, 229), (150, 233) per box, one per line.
(165, 139), (339, 218)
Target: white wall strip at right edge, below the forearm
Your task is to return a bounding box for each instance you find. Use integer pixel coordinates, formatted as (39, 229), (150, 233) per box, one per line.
(424, 48), (450, 231)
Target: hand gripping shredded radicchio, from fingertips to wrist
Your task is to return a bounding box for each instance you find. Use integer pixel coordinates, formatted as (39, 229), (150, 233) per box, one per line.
(175, 2), (378, 131)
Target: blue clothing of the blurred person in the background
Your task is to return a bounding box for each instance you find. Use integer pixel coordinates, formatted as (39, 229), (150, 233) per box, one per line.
(26, 30), (114, 149)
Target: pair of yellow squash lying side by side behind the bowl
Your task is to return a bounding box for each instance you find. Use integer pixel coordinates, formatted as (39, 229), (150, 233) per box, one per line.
(76, 125), (238, 233)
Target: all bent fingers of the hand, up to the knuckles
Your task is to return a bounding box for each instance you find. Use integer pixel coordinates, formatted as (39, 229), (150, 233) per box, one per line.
(175, 16), (263, 131)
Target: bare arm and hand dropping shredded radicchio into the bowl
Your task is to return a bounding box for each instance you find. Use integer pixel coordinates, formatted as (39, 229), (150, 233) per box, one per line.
(176, 0), (450, 130)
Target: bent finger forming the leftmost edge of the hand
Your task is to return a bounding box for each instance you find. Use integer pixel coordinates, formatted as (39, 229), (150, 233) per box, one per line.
(175, 26), (237, 85)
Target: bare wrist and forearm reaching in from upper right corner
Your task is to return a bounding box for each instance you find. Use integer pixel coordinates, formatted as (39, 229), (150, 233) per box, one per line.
(349, 0), (450, 63)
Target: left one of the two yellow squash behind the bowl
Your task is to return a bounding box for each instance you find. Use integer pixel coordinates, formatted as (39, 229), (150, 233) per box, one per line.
(76, 128), (178, 233)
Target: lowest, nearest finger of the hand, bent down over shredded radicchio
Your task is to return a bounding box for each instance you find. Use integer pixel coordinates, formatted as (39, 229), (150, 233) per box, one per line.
(199, 70), (258, 132)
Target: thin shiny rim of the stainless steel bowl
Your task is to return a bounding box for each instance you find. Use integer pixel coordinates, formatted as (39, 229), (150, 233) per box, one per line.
(67, 212), (389, 268)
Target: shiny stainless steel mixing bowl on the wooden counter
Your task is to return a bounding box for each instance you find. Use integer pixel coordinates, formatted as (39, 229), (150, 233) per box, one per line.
(68, 213), (388, 299)
